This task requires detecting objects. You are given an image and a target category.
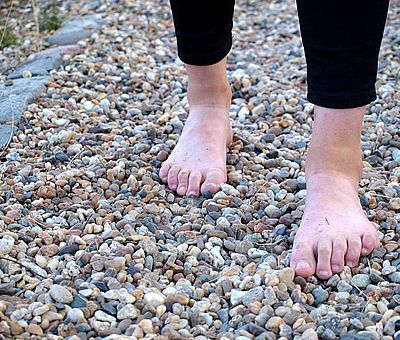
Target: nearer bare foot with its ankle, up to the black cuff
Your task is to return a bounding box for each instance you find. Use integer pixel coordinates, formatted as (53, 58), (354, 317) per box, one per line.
(290, 107), (380, 280)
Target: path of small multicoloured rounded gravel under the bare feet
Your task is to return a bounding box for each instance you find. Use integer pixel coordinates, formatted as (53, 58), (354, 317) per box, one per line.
(0, 0), (400, 340)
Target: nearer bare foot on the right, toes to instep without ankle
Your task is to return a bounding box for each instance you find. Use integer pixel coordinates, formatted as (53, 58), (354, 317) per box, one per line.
(291, 171), (380, 280)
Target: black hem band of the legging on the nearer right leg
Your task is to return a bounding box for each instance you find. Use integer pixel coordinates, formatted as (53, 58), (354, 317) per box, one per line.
(307, 89), (376, 109)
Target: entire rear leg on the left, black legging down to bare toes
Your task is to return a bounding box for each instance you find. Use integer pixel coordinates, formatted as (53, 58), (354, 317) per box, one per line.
(160, 0), (234, 196)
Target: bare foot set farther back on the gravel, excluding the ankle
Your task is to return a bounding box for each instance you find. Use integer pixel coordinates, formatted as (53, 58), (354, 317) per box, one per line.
(160, 105), (232, 196)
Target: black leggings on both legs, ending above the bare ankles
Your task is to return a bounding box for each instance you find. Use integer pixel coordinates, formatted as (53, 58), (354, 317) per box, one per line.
(170, 0), (389, 108)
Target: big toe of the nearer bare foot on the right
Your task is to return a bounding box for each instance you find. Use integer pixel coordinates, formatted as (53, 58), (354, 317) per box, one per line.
(290, 239), (315, 277)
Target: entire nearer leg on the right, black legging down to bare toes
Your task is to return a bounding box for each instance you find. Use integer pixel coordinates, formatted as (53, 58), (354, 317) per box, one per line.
(291, 0), (388, 279)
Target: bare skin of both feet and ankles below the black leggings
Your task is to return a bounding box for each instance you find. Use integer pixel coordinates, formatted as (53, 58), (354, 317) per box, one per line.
(160, 59), (380, 279)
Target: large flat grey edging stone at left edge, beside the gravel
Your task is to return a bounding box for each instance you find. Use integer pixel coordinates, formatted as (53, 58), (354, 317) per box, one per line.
(0, 76), (50, 124)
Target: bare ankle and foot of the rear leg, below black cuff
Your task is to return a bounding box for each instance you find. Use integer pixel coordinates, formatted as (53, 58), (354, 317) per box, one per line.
(160, 58), (232, 196)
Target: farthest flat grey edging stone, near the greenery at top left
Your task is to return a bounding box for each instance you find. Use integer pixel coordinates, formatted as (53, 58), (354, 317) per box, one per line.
(47, 14), (102, 45)
